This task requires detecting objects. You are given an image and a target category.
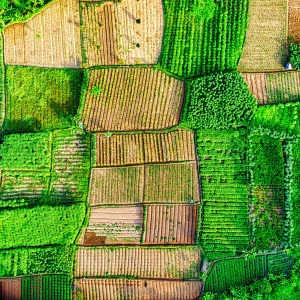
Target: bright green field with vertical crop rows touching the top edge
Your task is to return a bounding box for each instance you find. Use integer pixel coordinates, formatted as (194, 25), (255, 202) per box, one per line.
(160, 0), (249, 78)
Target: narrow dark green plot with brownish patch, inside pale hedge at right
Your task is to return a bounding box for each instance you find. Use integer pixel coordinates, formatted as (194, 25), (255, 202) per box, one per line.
(249, 133), (285, 250)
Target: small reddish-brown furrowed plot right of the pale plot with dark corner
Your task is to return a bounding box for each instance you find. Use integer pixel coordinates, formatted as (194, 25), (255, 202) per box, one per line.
(145, 205), (198, 244)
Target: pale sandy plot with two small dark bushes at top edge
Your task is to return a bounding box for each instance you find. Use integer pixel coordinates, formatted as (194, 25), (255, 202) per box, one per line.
(116, 0), (164, 65)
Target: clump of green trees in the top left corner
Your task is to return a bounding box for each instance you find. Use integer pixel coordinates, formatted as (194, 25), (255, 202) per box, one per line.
(0, 0), (51, 29)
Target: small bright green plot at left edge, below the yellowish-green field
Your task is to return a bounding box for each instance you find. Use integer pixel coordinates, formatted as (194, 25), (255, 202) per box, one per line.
(0, 132), (51, 171)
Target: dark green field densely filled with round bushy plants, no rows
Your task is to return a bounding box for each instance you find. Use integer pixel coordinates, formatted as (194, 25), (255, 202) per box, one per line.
(182, 72), (257, 129)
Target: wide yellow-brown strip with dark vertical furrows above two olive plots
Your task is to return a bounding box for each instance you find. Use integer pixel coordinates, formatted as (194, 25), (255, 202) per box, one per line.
(93, 130), (196, 167)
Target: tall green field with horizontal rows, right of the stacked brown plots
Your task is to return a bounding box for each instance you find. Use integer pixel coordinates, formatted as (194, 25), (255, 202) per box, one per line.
(197, 130), (249, 258)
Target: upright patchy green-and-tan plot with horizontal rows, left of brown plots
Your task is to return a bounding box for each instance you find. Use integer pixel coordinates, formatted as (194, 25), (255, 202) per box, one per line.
(50, 129), (90, 203)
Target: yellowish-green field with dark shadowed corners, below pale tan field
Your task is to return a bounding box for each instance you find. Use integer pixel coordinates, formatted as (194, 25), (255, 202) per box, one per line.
(4, 66), (83, 133)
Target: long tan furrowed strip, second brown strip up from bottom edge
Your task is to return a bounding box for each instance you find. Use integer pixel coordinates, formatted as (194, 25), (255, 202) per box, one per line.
(75, 246), (200, 279)
